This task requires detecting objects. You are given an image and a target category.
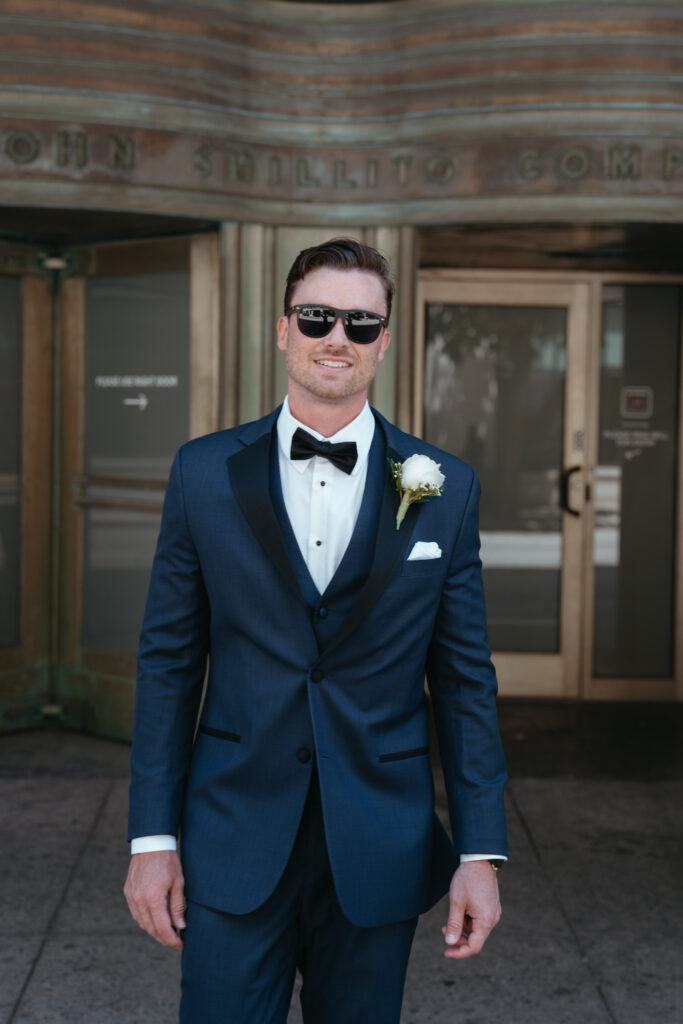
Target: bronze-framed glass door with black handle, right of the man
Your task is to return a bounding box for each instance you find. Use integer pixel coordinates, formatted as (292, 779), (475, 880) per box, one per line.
(415, 271), (591, 697)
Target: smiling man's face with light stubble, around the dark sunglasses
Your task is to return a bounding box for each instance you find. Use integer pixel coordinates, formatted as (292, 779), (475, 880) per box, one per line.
(278, 267), (391, 401)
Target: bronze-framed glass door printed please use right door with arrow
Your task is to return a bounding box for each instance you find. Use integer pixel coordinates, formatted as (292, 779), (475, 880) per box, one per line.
(58, 236), (218, 737)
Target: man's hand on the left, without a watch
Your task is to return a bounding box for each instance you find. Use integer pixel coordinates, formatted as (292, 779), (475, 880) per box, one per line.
(123, 850), (185, 949)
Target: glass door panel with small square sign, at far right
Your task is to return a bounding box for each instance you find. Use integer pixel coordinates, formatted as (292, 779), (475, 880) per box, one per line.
(585, 275), (683, 700)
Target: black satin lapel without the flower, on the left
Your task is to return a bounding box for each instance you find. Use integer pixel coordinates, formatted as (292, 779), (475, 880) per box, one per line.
(227, 431), (305, 604)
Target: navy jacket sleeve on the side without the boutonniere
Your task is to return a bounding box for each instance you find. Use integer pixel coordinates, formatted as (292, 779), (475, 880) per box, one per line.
(128, 449), (209, 839)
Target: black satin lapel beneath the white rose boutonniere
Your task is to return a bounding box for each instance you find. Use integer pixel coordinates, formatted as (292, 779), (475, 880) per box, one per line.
(322, 447), (418, 655)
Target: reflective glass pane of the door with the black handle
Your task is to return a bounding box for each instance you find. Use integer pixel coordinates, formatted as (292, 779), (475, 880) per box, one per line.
(425, 303), (566, 651)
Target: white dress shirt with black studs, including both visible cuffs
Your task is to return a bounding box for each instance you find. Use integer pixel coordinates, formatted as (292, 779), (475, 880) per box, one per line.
(130, 397), (498, 861)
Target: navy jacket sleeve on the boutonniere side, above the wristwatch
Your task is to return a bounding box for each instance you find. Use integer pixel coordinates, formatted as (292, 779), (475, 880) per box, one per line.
(427, 471), (508, 856)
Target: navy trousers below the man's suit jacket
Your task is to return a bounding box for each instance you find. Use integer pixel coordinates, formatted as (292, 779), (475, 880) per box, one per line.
(180, 770), (417, 1024)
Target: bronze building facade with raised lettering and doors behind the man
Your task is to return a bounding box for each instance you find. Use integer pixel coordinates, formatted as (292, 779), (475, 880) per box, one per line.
(0, 0), (683, 737)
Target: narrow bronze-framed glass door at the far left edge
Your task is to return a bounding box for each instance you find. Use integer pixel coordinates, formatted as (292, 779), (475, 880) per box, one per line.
(0, 243), (53, 731)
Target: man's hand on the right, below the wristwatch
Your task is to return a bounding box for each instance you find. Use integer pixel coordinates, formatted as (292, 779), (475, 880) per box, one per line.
(441, 860), (501, 959)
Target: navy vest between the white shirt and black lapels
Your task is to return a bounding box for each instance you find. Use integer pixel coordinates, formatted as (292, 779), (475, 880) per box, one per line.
(270, 425), (389, 650)
